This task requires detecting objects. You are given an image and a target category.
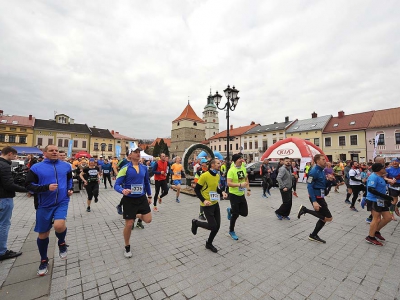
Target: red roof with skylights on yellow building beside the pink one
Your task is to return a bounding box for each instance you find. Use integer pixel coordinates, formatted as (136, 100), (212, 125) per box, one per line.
(324, 111), (374, 133)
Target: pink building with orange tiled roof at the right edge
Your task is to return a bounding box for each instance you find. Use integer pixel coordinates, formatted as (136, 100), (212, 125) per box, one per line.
(366, 107), (400, 161)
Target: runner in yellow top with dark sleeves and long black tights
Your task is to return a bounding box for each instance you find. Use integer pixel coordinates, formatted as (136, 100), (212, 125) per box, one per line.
(192, 158), (227, 253)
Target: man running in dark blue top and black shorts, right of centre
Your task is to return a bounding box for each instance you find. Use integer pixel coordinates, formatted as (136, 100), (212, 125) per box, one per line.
(297, 154), (333, 244)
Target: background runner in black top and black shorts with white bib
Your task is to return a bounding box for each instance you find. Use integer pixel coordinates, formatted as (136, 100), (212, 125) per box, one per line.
(79, 158), (100, 212)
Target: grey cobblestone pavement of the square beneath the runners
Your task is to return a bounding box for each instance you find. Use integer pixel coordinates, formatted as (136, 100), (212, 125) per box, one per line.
(0, 184), (400, 300)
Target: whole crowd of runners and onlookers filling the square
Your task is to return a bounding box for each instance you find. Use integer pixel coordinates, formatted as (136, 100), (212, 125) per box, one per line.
(0, 145), (400, 276)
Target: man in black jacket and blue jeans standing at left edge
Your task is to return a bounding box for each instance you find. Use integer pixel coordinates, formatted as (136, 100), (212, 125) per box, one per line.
(0, 147), (27, 260)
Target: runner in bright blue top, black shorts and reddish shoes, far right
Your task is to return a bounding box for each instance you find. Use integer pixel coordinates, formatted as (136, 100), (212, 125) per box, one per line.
(365, 163), (397, 246)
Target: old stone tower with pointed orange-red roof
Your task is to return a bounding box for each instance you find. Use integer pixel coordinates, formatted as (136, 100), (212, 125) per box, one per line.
(169, 103), (206, 157)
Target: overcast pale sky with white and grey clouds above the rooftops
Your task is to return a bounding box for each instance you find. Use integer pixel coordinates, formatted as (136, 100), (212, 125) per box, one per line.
(0, 0), (400, 139)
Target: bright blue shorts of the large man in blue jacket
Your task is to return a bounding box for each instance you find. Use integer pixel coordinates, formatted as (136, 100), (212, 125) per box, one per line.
(34, 202), (69, 233)
